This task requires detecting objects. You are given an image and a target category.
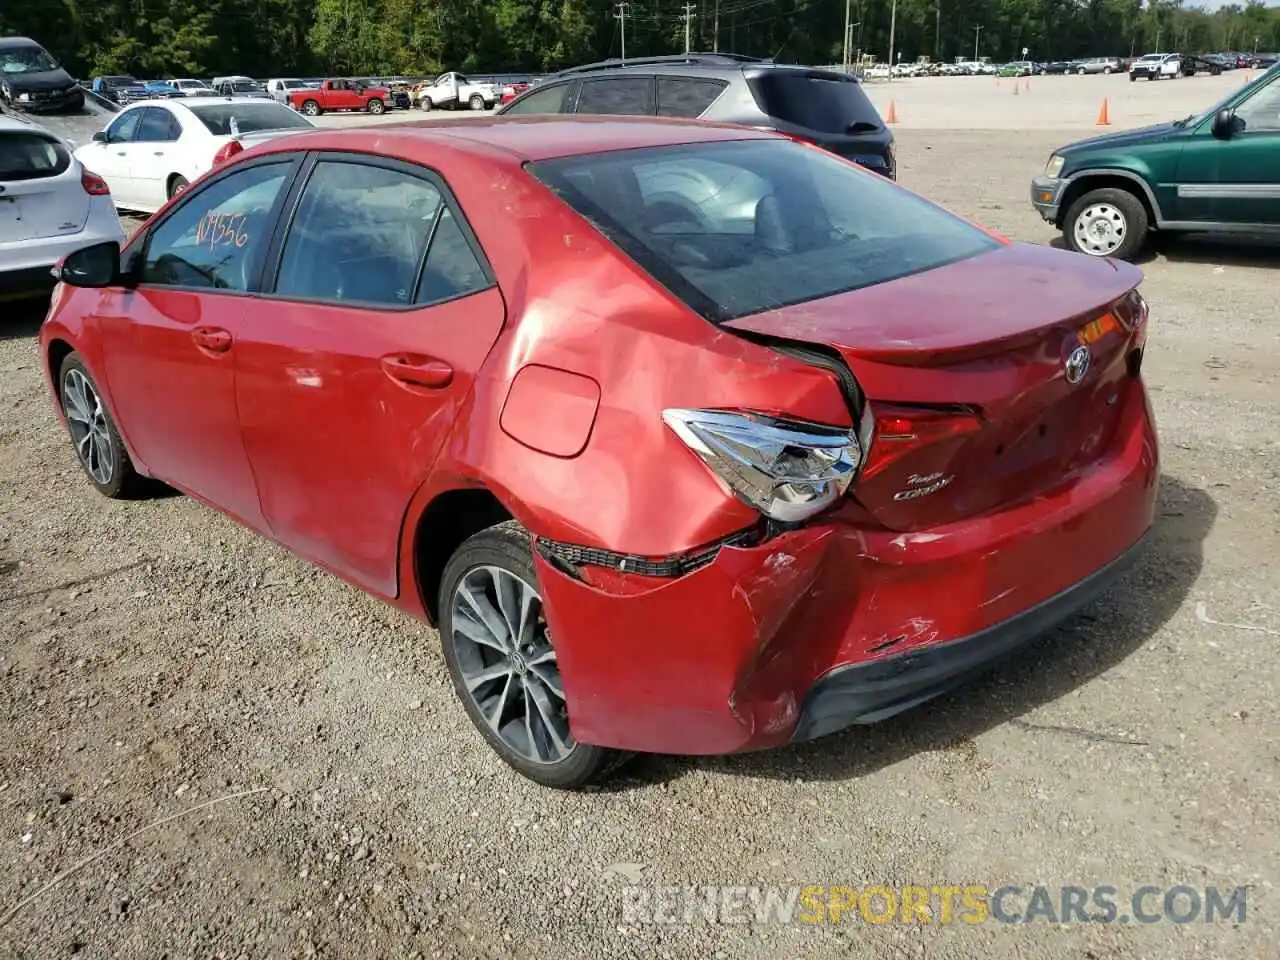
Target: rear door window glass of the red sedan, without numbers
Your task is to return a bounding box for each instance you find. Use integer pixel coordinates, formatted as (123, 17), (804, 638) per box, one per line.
(275, 160), (488, 306)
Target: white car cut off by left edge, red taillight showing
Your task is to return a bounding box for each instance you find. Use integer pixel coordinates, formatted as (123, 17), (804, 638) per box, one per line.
(0, 116), (124, 293)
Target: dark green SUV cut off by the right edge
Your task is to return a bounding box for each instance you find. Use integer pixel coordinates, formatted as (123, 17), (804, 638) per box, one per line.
(1032, 64), (1280, 260)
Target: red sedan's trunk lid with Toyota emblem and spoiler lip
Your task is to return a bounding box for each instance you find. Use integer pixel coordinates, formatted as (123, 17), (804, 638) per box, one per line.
(726, 244), (1142, 531)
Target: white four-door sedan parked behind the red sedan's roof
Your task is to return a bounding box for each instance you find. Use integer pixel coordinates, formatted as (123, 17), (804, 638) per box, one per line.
(76, 96), (315, 214)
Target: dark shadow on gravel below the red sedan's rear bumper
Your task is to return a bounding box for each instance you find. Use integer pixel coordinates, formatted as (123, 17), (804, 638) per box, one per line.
(629, 475), (1217, 790)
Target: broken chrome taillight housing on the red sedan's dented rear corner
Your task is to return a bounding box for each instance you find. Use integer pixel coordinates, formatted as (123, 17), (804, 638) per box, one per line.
(662, 410), (863, 524)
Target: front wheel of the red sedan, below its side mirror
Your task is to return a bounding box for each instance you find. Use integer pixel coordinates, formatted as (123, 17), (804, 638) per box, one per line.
(58, 352), (142, 500)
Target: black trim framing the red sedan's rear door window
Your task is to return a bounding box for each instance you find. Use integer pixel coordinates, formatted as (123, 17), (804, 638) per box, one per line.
(255, 150), (498, 314)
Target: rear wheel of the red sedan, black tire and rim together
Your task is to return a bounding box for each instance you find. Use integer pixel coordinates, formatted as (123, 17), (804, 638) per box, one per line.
(438, 521), (630, 790)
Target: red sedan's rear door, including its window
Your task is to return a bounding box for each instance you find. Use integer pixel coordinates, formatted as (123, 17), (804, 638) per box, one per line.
(237, 155), (506, 596)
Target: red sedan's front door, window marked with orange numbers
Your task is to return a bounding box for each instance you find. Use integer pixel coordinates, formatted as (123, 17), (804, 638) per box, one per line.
(96, 159), (296, 529)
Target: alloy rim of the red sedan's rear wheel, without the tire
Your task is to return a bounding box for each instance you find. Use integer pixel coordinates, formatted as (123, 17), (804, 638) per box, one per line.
(451, 566), (576, 763)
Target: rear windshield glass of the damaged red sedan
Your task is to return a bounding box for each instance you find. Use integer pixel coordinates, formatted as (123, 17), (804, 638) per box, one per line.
(529, 140), (1000, 321)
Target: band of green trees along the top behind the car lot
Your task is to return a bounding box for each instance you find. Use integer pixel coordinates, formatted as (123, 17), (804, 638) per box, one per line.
(0, 0), (1280, 77)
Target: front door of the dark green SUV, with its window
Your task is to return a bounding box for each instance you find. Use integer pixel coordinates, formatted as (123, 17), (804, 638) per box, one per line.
(1174, 74), (1280, 227)
